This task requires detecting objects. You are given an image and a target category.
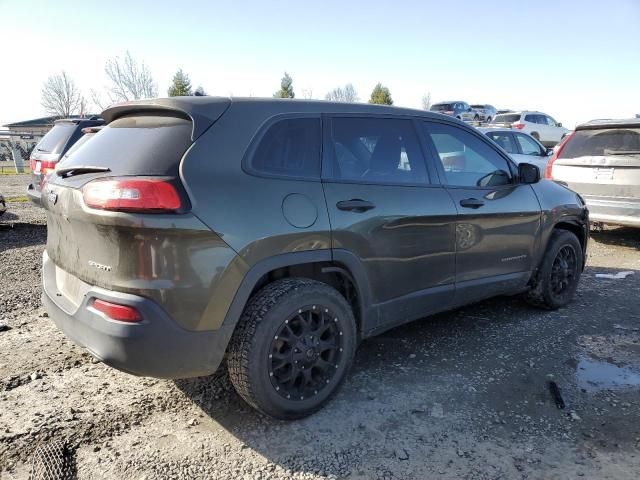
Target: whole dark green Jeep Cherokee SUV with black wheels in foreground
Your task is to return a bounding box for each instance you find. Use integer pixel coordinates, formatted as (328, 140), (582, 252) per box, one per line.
(42, 97), (588, 419)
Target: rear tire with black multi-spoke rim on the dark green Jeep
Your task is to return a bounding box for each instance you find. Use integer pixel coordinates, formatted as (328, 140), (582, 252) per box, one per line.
(227, 278), (356, 420)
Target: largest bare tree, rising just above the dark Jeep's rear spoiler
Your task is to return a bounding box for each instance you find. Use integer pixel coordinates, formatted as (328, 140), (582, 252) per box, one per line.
(104, 51), (158, 102)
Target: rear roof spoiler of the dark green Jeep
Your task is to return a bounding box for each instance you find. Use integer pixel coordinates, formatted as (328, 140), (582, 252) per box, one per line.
(102, 97), (231, 141)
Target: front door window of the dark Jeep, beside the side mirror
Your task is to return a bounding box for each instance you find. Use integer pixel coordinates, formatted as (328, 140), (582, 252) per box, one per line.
(425, 123), (511, 187)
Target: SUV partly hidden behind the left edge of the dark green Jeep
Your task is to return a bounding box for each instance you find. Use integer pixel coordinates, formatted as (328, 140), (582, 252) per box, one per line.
(27, 116), (104, 205)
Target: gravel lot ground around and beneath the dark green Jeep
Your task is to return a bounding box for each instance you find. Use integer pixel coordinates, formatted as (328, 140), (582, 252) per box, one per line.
(0, 176), (640, 480)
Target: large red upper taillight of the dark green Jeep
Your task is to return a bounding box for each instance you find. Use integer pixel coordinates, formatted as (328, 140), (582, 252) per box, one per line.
(82, 178), (182, 213)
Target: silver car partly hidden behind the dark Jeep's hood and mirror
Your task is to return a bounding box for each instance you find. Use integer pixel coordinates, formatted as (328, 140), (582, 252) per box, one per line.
(478, 127), (553, 175)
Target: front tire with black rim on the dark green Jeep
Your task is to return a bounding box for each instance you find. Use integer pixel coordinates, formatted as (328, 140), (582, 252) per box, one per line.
(526, 230), (583, 310)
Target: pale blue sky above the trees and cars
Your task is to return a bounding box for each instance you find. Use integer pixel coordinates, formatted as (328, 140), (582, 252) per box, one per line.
(0, 0), (640, 128)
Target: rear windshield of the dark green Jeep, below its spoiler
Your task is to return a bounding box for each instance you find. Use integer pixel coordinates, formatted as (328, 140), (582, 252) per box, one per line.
(64, 113), (191, 176)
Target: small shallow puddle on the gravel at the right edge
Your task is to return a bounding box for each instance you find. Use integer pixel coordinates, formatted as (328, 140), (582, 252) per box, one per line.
(576, 358), (640, 392)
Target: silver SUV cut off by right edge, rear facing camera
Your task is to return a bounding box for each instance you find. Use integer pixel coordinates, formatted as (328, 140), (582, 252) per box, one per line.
(546, 118), (640, 227)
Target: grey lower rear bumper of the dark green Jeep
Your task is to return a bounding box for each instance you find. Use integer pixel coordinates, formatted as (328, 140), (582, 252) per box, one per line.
(42, 252), (233, 378)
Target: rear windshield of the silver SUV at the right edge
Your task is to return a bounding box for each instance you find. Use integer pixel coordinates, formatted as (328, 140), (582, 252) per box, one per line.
(558, 128), (640, 158)
